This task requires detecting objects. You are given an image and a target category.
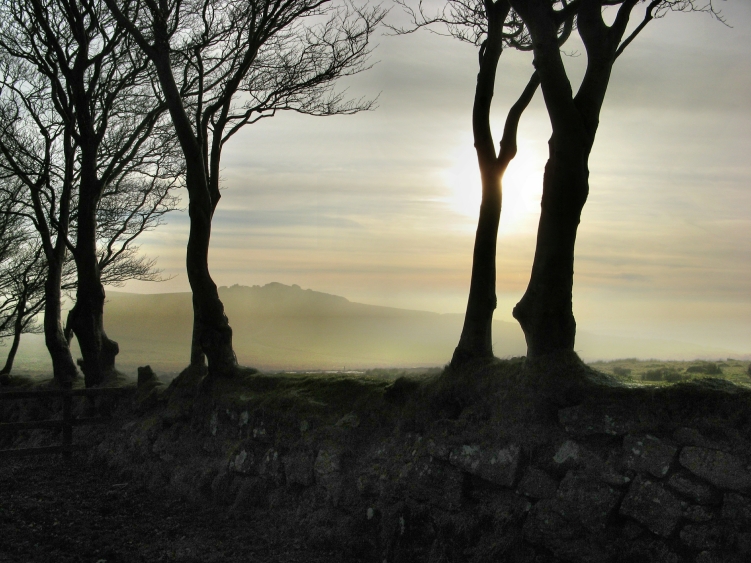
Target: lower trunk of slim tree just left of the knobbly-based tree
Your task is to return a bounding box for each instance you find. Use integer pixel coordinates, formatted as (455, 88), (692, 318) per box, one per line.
(44, 259), (78, 383)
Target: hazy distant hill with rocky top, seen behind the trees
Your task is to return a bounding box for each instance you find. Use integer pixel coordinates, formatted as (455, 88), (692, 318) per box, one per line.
(0, 283), (743, 373)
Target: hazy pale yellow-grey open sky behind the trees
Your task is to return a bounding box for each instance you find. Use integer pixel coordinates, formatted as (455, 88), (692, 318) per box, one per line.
(125, 0), (751, 353)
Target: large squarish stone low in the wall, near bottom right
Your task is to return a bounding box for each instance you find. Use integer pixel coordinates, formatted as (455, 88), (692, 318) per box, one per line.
(620, 475), (681, 536)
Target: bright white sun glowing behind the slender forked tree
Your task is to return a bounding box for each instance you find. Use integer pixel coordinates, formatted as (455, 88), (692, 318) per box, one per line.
(443, 135), (545, 234)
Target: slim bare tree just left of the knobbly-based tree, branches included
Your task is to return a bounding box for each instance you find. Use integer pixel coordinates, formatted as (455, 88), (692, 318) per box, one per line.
(0, 56), (77, 382)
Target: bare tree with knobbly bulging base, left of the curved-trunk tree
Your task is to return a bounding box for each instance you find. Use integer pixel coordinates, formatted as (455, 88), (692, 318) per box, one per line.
(0, 0), (181, 385)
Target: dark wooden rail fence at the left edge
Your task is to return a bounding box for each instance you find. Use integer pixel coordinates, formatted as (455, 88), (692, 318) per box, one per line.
(0, 383), (128, 458)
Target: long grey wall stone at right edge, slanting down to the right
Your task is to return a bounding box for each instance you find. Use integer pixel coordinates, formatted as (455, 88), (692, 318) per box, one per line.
(678, 446), (751, 491)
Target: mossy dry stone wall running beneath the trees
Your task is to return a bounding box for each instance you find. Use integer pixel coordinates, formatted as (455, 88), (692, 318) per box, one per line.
(5, 372), (751, 563)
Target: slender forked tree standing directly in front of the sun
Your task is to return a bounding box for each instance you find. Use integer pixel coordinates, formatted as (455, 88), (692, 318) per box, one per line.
(392, 0), (573, 367)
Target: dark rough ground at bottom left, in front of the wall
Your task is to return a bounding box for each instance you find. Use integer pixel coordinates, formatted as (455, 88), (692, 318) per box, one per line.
(0, 455), (342, 563)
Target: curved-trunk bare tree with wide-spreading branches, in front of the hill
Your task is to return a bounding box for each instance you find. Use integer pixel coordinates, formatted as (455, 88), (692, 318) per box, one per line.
(105, 0), (383, 377)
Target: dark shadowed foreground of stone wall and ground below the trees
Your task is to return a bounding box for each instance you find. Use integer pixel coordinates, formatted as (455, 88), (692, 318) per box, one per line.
(0, 357), (751, 563)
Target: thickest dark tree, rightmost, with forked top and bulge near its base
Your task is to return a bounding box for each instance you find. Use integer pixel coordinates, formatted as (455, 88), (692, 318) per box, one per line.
(508, 0), (719, 358)
